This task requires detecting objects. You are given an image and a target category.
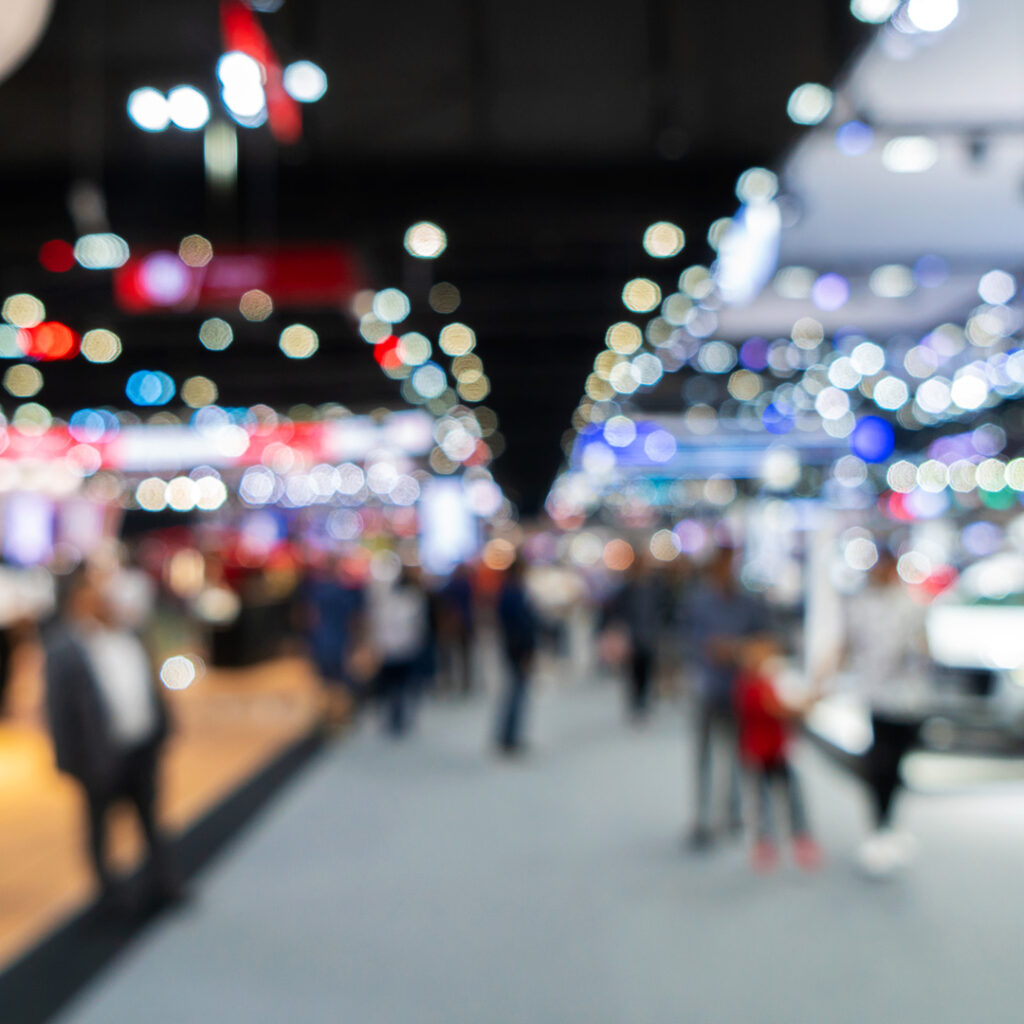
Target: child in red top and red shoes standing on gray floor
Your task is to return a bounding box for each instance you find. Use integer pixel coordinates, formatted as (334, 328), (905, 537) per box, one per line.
(733, 634), (821, 871)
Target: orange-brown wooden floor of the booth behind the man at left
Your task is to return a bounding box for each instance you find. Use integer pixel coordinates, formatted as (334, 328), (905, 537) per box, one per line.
(0, 651), (324, 970)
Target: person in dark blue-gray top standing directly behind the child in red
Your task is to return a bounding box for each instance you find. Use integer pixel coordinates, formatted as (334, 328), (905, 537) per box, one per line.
(682, 547), (767, 849)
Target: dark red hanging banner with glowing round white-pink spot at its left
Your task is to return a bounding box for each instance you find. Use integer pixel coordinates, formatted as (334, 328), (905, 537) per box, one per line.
(114, 245), (366, 313)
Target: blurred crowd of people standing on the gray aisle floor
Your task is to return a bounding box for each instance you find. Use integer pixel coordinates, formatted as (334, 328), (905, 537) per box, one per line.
(292, 545), (927, 876)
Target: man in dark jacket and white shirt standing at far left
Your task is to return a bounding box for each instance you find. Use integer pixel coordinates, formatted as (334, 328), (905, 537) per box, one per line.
(43, 566), (177, 908)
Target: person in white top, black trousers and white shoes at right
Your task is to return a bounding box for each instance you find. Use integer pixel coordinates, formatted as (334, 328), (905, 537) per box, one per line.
(845, 551), (928, 876)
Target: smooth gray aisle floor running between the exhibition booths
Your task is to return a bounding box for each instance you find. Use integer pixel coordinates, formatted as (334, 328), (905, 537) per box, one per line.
(62, 671), (1024, 1024)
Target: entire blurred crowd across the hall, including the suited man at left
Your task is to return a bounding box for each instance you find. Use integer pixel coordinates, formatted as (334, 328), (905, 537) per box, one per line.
(16, 528), (926, 921)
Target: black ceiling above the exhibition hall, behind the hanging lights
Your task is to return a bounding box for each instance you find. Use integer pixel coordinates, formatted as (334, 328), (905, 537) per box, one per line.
(0, 0), (863, 511)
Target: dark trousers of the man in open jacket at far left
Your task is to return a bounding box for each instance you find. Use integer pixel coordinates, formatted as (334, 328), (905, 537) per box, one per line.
(86, 743), (170, 893)
